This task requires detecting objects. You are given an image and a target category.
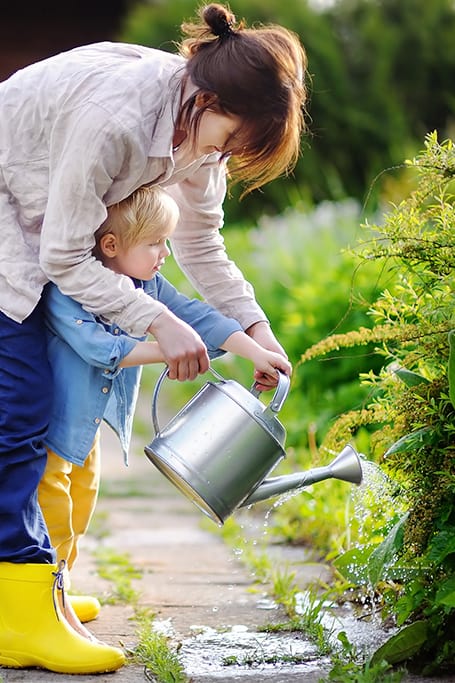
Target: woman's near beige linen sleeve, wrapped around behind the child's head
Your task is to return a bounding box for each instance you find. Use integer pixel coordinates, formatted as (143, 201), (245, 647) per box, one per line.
(40, 104), (167, 336)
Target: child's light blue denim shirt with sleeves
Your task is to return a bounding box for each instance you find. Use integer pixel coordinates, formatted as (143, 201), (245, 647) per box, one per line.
(44, 273), (242, 465)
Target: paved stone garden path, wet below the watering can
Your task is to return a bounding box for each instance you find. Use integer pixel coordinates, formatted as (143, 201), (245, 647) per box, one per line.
(0, 428), (455, 683)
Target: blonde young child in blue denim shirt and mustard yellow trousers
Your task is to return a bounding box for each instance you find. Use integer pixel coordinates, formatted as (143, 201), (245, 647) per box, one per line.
(38, 186), (291, 621)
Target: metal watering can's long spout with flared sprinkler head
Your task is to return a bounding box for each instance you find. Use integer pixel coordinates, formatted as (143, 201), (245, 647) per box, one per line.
(239, 444), (363, 507)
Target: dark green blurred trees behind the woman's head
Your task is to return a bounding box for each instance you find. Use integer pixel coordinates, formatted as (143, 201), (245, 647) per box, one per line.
(119, 0), (455, 225)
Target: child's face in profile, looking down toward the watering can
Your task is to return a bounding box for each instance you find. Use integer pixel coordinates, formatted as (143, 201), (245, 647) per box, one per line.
(104, 235), (170, 280)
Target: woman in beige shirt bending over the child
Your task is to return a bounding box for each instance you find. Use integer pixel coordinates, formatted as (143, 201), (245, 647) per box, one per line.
(0, 4), (306, 673)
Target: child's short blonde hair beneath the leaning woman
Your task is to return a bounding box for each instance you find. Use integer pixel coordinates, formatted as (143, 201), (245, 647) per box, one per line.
(95, 185), (179, 255)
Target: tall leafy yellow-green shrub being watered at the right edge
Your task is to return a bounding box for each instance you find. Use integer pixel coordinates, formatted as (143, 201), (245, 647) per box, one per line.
(302, 133), (455, 673)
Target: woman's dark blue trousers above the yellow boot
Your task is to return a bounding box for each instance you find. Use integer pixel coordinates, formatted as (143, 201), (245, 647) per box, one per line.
(0, 304), (55, 564)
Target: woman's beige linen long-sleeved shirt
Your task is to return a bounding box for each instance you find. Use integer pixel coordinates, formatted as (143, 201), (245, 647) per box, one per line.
(0, 42), (266, 335)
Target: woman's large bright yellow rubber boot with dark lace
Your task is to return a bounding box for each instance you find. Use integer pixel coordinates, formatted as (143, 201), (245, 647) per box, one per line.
(0, 562), (125, 674)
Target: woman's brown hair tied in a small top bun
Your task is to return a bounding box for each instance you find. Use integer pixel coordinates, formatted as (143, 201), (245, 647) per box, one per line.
(179, 4), (307, 191)
